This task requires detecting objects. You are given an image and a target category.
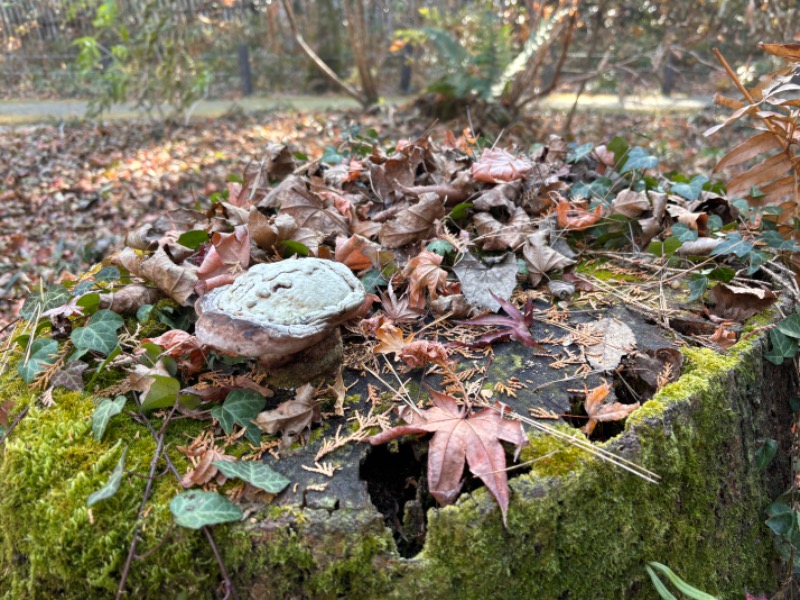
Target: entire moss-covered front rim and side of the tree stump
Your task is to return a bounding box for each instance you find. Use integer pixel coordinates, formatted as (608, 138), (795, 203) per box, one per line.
(0, 316), (794, 599)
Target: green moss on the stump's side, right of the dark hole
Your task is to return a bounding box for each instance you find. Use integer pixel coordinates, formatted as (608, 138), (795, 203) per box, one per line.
(396, 332), (777, 599)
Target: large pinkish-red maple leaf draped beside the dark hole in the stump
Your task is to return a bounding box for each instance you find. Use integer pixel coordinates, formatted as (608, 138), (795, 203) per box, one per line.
(367, 390), (528, 525)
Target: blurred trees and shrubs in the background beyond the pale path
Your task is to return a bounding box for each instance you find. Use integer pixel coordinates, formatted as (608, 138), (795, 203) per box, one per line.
(0, 0), (800, 121)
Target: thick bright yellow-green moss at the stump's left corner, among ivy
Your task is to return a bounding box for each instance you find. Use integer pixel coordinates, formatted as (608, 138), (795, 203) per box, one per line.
(0, 350), (250, 599)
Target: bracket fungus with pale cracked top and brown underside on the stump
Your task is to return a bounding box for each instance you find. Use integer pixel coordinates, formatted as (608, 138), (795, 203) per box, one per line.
(195, 258), (366, 385)
